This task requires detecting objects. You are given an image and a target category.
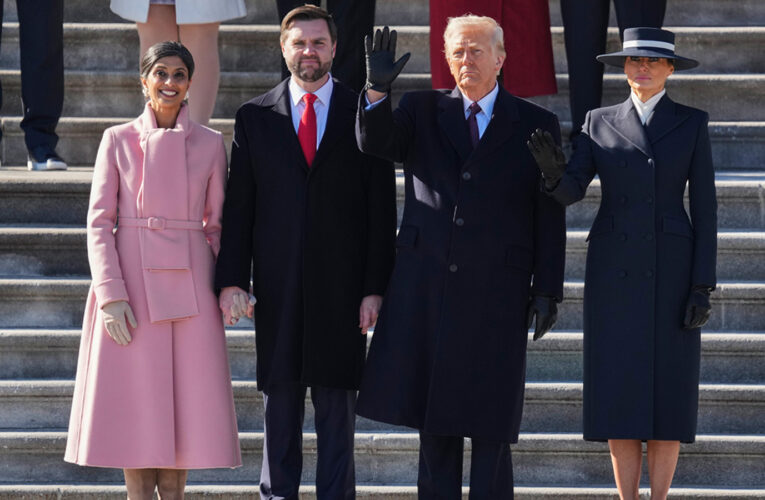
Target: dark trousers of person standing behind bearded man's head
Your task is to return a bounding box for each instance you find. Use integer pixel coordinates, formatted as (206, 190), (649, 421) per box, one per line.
(276, 0), (375, 92)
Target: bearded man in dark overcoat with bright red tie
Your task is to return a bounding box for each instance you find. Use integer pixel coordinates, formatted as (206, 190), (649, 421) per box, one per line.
(216, 6), (396, 500)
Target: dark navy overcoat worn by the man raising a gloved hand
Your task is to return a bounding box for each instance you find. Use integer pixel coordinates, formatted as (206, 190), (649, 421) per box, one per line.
(357, 89), (565, 442)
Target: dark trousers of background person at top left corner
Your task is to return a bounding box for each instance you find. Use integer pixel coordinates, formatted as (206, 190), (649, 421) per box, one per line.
(0, 0), (64, 150)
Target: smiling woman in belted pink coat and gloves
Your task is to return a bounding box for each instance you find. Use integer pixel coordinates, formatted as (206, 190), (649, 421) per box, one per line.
(65, 42), (241, 500)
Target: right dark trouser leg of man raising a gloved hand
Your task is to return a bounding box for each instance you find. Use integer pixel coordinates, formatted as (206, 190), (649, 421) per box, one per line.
(470, 439), (513, 500)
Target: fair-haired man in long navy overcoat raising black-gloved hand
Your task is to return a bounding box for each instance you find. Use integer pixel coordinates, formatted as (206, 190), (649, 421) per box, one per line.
(357, 16), (566, 500)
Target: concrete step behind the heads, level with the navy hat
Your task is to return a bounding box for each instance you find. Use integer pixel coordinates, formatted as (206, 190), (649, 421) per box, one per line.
(0, 23), (765, 73)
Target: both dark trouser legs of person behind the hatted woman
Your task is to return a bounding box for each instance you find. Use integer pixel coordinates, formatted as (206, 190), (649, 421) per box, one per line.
(560, 0), (667, 139)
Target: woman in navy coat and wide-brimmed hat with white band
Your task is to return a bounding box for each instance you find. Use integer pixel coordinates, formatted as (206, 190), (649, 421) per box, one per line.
(529, 28), (717, 499)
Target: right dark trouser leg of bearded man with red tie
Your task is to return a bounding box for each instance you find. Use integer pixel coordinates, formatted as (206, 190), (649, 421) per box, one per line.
(311, 387), (356, 500)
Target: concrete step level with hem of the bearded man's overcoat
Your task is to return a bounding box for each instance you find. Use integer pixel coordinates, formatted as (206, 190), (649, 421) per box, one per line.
(0, 380), (765, 434)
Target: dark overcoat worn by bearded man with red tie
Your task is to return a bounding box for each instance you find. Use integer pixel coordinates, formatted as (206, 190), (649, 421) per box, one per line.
(215, 80), (396, 394)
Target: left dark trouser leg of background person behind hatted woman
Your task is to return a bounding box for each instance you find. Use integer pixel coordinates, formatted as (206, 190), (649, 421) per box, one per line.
(560, 0), (610, 140)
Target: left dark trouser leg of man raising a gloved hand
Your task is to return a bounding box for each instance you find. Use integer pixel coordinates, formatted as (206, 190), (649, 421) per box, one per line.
(417, 431), (465, 500)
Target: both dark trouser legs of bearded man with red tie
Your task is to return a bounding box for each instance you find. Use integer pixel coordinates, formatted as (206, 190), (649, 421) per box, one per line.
(260, 384), (356, 500)
